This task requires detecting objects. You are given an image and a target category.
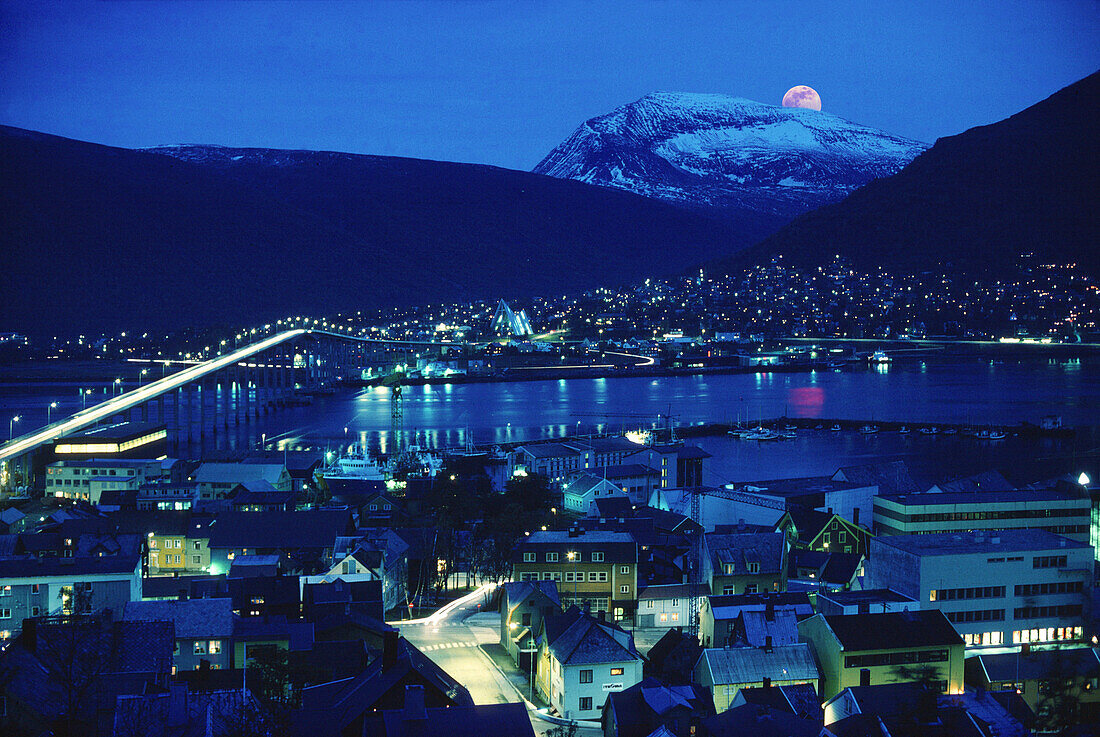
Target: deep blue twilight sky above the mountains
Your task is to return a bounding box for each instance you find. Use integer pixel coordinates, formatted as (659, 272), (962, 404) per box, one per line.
(0, 0), (1100, 169)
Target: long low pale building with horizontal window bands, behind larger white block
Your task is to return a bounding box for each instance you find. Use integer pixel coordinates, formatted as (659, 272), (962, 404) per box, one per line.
(875, 483), (1092, 542)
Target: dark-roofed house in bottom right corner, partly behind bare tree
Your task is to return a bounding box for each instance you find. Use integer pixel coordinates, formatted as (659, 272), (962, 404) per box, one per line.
(965, 648), (1100, 732)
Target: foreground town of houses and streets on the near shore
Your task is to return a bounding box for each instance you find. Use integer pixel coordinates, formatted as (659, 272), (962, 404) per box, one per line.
(0, 425), (1100, 737)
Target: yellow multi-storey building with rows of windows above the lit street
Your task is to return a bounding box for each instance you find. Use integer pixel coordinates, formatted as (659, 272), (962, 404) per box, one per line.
(512, 528), (638, 622)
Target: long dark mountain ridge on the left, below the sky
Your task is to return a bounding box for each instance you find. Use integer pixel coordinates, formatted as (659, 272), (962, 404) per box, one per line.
(0, 128), (748, 333)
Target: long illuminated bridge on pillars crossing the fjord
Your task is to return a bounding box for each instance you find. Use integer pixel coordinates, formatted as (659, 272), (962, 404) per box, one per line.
(0, 328), (463, 490)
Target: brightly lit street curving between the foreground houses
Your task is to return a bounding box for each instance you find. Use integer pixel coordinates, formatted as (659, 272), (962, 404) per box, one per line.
(391, 586), (603, 737)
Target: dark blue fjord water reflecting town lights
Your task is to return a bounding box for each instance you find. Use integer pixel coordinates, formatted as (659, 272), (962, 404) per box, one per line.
(0, 356), (1100, 484)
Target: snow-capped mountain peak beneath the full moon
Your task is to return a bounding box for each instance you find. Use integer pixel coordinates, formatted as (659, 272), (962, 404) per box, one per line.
(534, 92), (927, 220)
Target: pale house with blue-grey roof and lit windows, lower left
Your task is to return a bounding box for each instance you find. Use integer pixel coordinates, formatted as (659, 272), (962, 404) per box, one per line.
(122, 598), (233, 672)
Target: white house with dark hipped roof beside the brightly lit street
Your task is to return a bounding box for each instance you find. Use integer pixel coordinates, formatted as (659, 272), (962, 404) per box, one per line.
(535, 606), (642, 719)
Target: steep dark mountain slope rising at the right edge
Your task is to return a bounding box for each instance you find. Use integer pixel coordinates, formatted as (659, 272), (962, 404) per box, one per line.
(718, 73), (1100, 274)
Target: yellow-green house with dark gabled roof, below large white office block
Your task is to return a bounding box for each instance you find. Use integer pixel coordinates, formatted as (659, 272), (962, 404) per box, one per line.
(799, 611), (964, 699)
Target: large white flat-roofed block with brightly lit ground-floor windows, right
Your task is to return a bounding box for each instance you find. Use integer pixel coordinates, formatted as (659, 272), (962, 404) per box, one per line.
(868, 529), (1092, 648)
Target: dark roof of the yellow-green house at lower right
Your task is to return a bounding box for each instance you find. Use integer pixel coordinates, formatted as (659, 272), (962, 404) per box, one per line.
(817, 609), (963, 651)
